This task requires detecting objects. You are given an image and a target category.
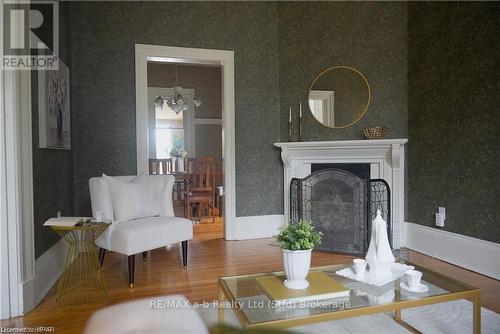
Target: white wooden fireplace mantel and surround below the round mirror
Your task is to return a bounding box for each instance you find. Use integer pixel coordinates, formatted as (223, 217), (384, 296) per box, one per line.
(274, 139), (407, 250)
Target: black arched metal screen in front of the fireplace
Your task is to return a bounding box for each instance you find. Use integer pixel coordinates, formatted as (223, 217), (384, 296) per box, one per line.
(290, 168), (390, 255)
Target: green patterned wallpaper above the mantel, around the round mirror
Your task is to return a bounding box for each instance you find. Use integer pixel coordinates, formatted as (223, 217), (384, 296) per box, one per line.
(278, 1), (407, 141)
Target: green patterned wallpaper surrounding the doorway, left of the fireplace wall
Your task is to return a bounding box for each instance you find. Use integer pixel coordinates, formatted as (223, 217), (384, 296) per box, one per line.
(71, 2), (283, 216)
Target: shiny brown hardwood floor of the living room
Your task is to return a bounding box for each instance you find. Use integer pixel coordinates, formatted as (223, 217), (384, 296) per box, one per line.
(1, 239), (500, 333)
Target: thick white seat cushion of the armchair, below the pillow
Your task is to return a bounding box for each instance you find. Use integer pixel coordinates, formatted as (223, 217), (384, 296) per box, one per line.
(96, 217), (193, 255)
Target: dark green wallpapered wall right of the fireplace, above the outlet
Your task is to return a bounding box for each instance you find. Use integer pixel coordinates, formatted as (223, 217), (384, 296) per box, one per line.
(408, 2), (500, 242)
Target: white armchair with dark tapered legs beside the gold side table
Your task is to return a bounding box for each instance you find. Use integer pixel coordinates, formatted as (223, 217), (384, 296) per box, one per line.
(89, 175), (193, 288)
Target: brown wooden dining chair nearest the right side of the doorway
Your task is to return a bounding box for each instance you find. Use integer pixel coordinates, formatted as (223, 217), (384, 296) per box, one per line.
(186, 157), (216, 223)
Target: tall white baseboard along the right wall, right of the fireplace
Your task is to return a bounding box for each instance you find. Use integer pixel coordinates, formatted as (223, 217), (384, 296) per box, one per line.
(405, 222), (500, 279)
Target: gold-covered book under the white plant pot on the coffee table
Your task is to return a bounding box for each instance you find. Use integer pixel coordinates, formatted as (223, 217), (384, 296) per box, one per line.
(257, 271), (349, 304)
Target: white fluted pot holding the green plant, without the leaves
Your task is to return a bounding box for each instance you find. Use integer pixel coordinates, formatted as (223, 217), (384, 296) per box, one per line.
(282, 249), (312, 289)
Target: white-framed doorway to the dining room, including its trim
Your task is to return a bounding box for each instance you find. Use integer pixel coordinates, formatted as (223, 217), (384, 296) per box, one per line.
(136, 44), (235, 240)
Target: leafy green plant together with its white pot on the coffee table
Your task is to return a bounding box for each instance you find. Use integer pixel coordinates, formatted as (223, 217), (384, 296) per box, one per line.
(276, 220), (322, 289)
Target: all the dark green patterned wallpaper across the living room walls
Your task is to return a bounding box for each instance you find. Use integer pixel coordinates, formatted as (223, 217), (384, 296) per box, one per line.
(34, 2), (500, 256)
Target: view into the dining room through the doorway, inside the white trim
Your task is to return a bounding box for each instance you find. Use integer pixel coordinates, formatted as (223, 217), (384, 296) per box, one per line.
(147, 59), (224, 239)
